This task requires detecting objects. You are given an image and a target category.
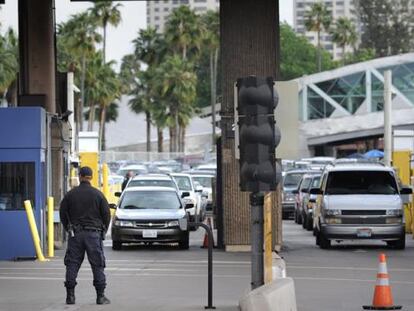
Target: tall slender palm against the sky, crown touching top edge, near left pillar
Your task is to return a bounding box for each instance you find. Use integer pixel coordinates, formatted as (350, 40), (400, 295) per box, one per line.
(90, 1), (122, 62)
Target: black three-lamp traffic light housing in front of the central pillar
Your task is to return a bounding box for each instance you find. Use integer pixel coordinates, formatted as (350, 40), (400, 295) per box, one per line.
(236, 76), (281, 192)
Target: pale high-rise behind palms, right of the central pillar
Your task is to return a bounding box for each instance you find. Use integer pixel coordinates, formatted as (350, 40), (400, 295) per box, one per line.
(293, 0), (358, 60)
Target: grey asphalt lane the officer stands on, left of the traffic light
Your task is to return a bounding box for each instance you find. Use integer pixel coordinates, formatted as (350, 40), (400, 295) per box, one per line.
(0, 229), (250, 311)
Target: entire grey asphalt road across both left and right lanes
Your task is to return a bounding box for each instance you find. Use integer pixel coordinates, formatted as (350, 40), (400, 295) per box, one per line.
(0, 221), (414, 311)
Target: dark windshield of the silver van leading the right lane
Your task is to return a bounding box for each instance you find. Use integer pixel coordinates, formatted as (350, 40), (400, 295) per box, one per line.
(325, 171), (398, 195)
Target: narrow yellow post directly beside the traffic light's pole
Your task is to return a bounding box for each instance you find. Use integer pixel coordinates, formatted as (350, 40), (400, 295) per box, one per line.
(264, 193), (273, 284)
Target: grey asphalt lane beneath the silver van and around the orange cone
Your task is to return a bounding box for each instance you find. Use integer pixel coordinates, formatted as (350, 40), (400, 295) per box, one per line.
(281, 221), (414, 311)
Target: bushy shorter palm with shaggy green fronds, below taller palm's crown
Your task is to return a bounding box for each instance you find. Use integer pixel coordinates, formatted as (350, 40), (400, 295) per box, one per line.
(155, 55), (197, 152)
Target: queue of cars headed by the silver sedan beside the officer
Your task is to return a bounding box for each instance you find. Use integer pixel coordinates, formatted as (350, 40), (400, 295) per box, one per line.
(107, 163), (214, 250)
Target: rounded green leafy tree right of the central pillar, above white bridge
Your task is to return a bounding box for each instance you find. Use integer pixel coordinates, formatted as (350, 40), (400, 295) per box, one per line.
(280, 23), (335, 80)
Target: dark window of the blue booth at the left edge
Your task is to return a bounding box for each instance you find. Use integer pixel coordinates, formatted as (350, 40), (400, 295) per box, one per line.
(0, 162), (35, 211)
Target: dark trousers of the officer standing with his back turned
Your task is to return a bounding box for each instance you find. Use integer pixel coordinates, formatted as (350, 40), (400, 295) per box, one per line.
(64, 230), (106, 291)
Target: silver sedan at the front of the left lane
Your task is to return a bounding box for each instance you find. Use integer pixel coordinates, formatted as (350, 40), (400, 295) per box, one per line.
(111, 187), (193, 250)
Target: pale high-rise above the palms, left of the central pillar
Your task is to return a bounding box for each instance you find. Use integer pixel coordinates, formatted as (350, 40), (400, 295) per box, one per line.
(147, 0), (220, 32)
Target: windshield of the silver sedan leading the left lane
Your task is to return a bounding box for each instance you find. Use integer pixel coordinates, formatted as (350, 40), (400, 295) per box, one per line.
(119, 191), (181, 209)
